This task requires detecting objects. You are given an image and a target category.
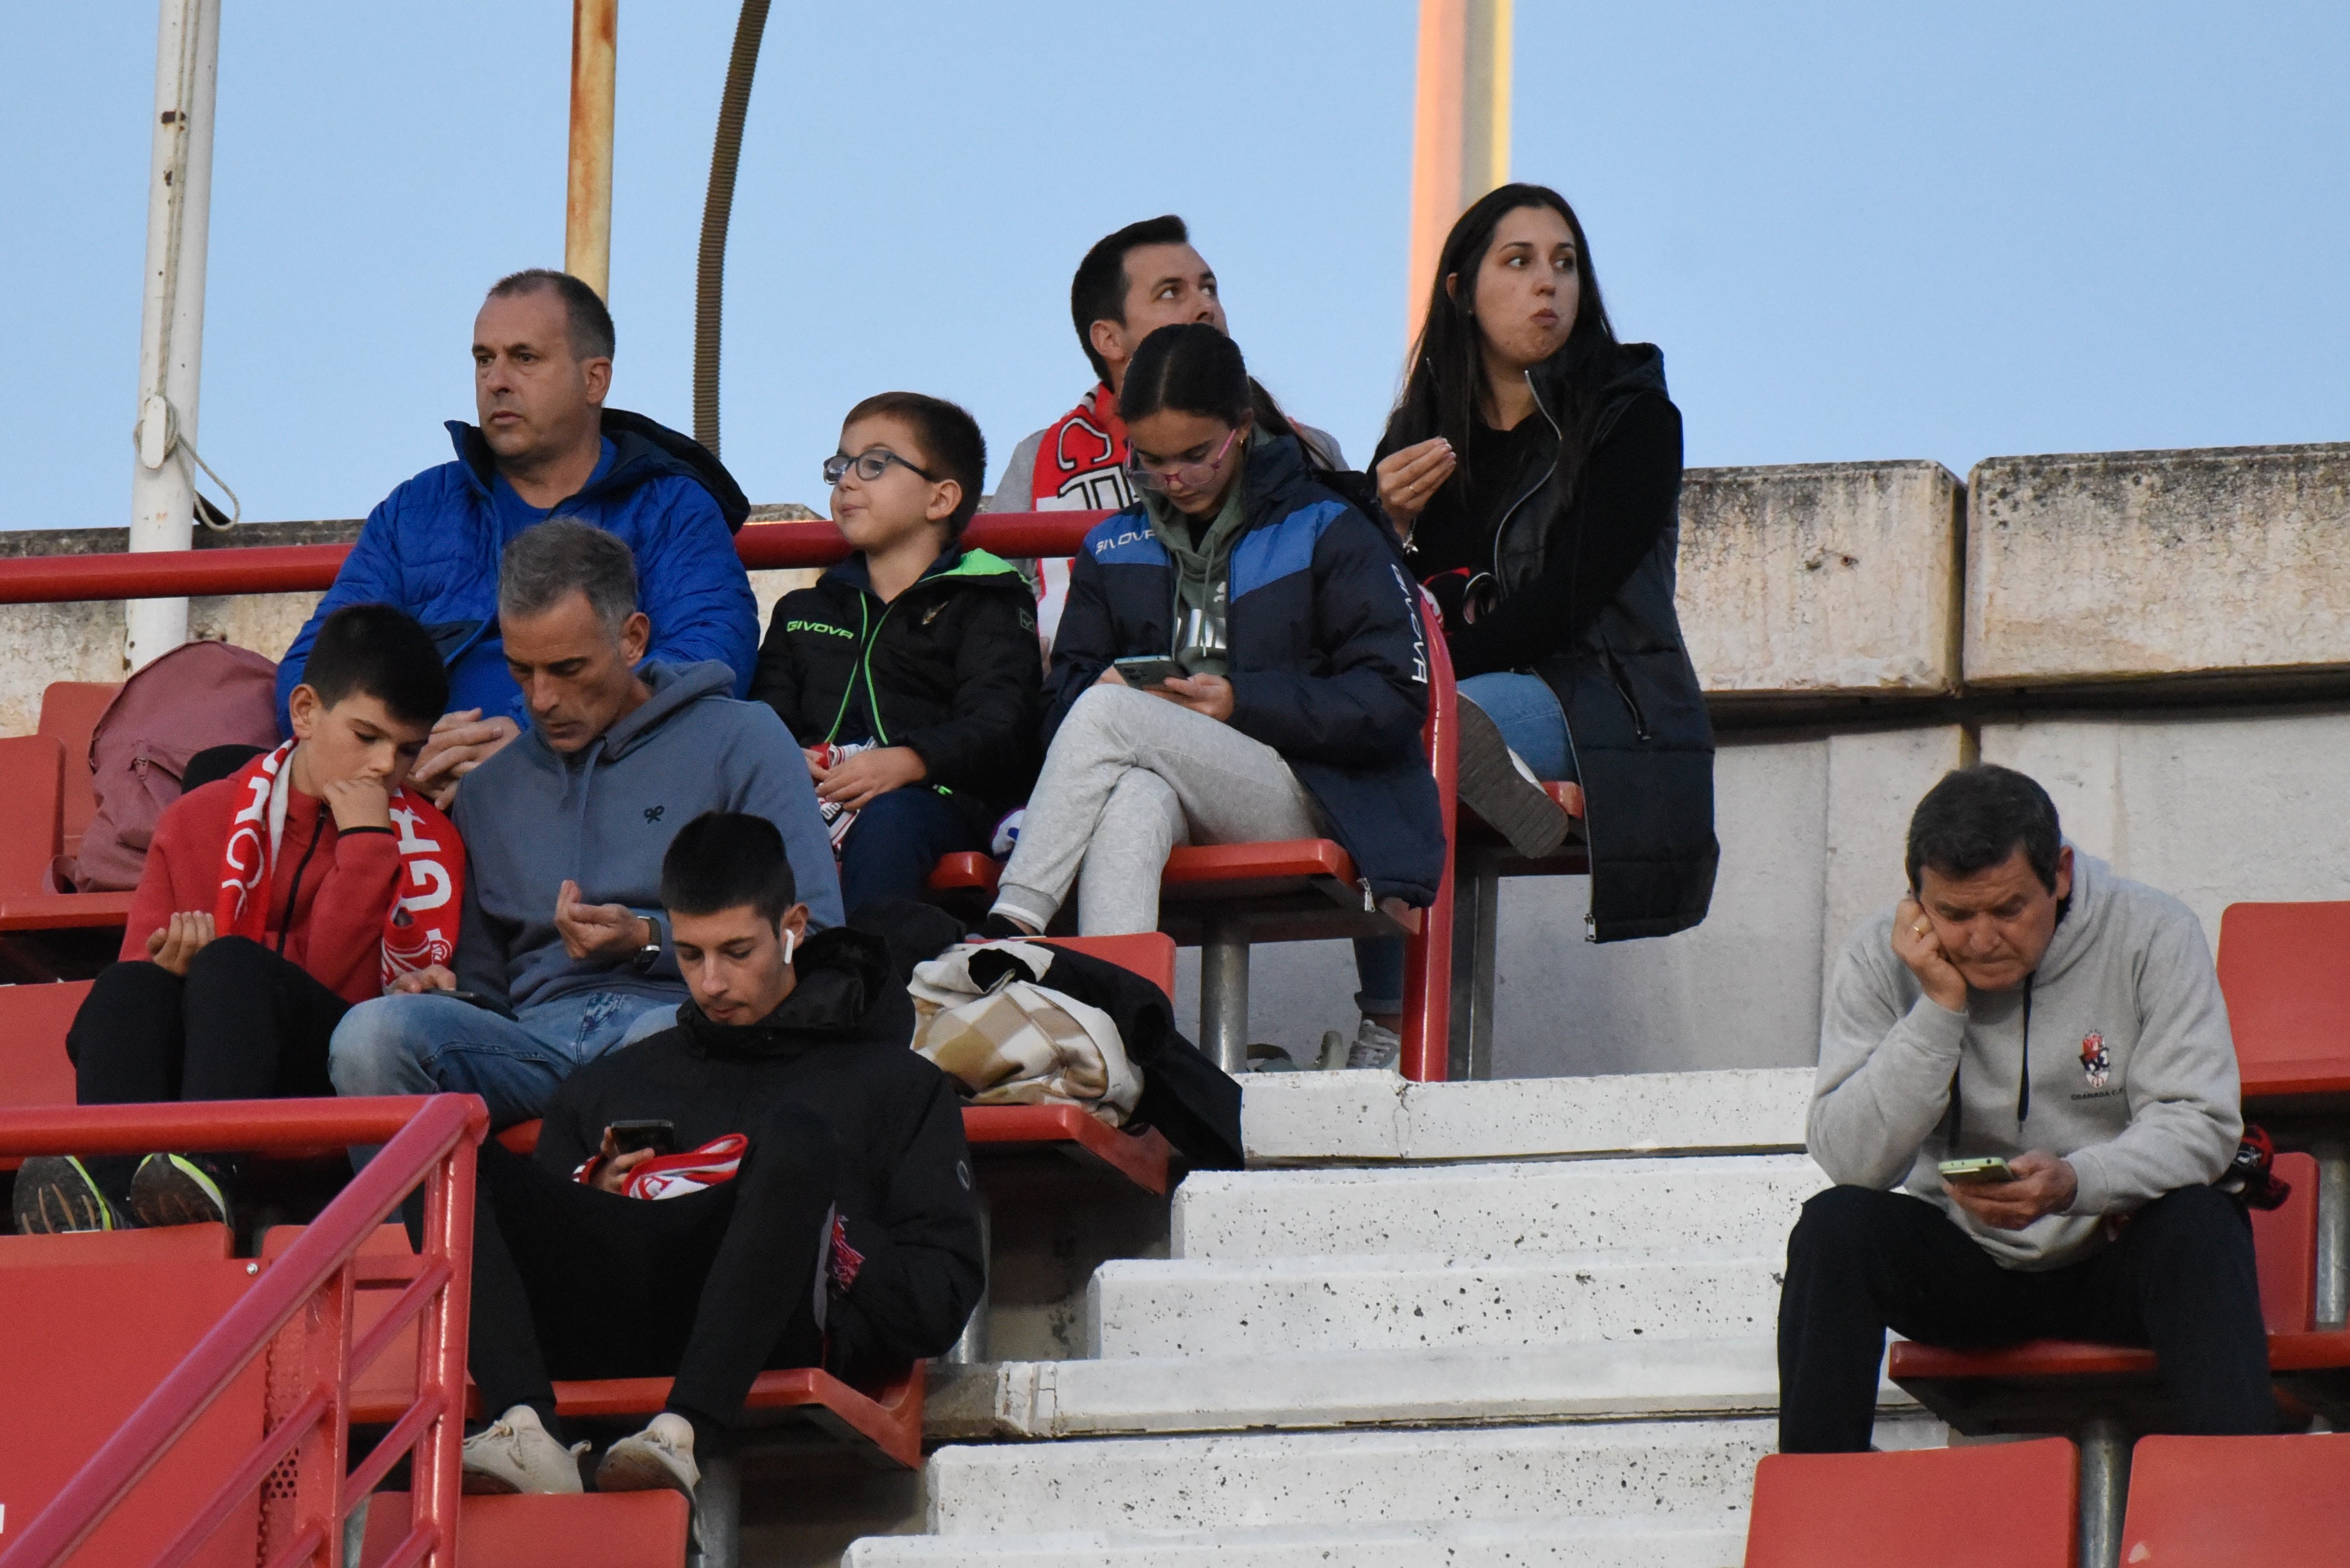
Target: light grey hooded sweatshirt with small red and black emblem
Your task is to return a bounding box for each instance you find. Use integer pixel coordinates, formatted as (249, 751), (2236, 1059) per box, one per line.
(1810, 851), (2244, 1269)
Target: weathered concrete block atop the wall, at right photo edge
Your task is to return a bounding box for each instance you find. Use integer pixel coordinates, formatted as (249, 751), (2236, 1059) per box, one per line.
(1964, 444), (2350, 684)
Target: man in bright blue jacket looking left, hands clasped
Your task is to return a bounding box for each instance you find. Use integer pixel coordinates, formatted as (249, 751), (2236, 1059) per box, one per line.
(278, 268), (759, 806)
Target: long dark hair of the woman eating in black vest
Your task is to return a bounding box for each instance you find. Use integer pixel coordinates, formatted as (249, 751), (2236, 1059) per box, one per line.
(1379, 183), (1617, 496)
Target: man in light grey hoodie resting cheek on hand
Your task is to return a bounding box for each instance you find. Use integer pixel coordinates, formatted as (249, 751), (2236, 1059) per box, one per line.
(1779, 764), (2275, 1453)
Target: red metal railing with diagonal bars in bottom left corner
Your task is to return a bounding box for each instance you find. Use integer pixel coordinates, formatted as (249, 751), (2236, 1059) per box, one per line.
(0, 1095), (489, 1568)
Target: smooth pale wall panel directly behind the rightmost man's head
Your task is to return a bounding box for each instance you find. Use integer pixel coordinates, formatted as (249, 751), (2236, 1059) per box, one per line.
(1983, 712), (2350, 947)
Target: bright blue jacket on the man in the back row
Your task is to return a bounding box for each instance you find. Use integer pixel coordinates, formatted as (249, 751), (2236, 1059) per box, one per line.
(278, 409), (759, 733)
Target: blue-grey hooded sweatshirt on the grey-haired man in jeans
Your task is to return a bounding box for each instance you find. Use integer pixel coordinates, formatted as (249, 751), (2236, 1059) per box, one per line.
(456, 661), (842, 1009)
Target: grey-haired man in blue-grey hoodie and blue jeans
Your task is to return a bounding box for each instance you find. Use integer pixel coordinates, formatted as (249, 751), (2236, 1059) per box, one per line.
(329, 520), (842, 1126)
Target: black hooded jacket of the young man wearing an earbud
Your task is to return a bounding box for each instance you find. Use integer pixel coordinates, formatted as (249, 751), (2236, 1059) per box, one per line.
(536, 926), (987, 1380)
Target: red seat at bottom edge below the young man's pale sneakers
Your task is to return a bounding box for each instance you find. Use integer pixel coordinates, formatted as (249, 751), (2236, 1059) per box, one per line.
(357, 1493), (693, 1568)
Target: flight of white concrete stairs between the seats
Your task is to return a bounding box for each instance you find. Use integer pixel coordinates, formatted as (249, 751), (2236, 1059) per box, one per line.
(843, 1072), (1943, 1568)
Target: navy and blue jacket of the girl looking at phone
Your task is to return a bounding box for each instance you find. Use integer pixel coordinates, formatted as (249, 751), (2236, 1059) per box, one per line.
(1044, 437), (1445, 907)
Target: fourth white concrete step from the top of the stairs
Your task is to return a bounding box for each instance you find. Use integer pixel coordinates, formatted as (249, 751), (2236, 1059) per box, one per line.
(996, 1335), (1918, 1436)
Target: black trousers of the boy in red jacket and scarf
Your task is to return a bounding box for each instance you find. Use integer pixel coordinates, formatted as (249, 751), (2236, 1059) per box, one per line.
(66, 936), (350, 1204)
